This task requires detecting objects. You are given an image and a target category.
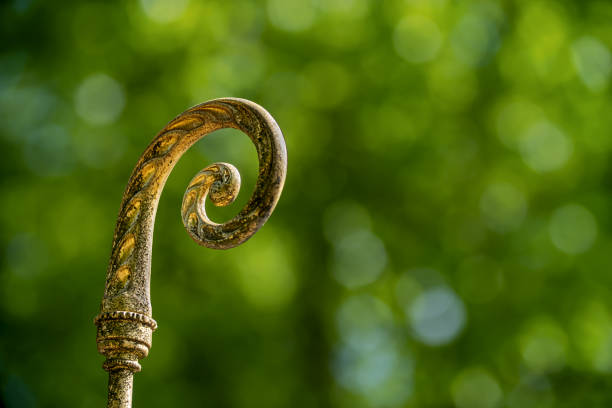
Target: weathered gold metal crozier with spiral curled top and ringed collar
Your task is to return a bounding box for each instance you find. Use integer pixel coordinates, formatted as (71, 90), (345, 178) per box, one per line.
(94, 98), (287, 408)
